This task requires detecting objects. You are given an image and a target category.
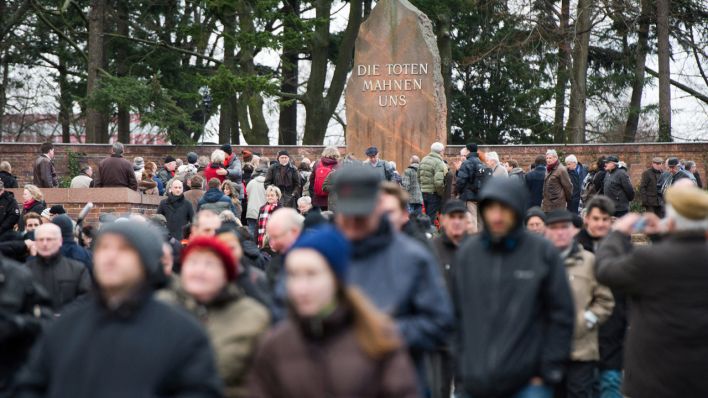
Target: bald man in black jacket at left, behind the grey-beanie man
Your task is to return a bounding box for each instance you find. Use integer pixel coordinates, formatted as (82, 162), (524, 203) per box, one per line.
(27, 223), (91, 314)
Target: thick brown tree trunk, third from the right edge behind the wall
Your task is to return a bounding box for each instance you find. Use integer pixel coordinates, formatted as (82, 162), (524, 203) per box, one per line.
(566, 0), (592, 144)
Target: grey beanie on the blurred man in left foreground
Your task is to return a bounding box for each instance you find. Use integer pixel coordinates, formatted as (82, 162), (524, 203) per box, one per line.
(96, 221), (167, 289)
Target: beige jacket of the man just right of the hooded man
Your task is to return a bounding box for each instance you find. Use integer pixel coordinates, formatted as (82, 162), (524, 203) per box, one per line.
(565, 244), (615, 361)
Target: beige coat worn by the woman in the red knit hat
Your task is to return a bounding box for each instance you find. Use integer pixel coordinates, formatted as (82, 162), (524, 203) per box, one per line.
(159, 285), (270, 398)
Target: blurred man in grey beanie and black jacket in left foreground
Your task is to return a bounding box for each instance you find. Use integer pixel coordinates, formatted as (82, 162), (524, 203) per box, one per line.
(15, 221), (222, 398)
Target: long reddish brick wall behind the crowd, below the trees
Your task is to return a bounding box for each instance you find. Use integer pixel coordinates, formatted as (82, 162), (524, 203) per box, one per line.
(0, 142), (708, 185)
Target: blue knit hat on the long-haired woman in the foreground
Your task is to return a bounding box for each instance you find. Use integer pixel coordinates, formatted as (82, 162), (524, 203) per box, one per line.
(290, 225), (351, 282)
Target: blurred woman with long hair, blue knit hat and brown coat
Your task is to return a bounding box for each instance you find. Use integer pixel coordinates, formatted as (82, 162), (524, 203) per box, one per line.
(250, 226), (418, 398)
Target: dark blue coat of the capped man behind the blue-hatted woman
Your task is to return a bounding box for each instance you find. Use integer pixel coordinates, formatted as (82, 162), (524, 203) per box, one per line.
(348, 218), (452, 365)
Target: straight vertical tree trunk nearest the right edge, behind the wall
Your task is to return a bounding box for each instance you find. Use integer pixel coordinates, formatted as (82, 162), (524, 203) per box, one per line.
(656, 0), (671, 142)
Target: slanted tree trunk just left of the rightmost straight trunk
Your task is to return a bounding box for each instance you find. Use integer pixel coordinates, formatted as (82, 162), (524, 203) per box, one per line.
(622, 0), (651, 142)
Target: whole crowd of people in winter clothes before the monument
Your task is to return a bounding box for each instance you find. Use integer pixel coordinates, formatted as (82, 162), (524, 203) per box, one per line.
(0, 143), (708, 398)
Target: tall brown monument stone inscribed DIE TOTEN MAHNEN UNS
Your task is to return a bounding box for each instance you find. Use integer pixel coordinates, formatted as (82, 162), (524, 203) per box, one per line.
(345, 0), (447, 172)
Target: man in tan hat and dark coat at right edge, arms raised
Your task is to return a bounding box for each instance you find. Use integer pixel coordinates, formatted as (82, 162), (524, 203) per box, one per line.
(597, 186), (708, 397)
